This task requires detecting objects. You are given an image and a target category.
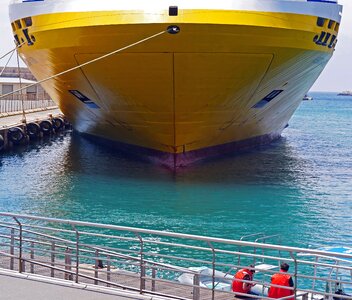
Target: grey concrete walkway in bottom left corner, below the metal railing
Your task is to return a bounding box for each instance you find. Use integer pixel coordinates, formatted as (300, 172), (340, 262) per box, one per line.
(0, 270), (170, 300)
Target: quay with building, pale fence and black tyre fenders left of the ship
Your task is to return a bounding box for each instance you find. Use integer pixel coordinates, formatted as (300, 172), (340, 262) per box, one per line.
(0, 65), (68, 151)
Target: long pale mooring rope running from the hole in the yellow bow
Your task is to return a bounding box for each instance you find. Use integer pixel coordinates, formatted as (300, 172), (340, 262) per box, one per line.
(0, 30), (168, 99)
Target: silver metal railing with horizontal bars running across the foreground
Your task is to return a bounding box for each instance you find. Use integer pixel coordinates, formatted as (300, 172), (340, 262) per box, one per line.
(0, 213), (352, 300)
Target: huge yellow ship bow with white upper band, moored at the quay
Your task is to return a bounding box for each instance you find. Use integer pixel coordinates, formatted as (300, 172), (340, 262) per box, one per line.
(9, 0), (342, 169)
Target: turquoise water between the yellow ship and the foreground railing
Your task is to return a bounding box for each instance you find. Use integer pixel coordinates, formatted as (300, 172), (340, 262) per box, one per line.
(0, 93), (352, 246)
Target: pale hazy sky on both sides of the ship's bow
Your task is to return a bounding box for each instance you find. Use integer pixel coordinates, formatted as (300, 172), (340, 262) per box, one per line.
(0, 0), (352, 92)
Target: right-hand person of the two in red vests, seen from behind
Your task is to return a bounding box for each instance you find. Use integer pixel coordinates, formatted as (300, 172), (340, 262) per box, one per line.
(268, 263), (294, 300)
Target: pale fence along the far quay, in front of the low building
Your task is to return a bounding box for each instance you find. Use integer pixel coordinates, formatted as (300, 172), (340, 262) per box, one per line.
(0, 94), (57, 114)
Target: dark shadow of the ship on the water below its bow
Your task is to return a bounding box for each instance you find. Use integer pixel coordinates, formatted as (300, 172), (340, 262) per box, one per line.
(65, 134), (307, 184)
